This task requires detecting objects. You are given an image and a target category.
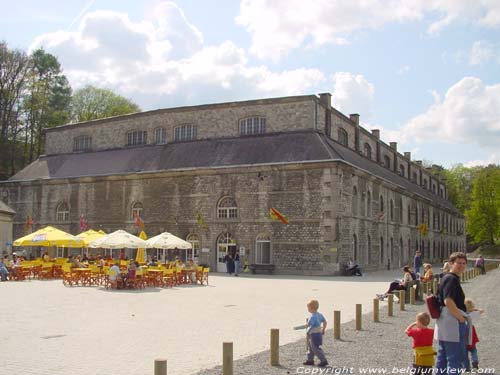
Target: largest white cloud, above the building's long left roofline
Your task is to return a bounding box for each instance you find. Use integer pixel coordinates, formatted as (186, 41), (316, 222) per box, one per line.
(31, 2), (325, 109)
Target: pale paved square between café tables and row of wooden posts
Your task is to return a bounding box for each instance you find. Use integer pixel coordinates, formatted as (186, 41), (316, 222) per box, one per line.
(0, 270), (444, 375)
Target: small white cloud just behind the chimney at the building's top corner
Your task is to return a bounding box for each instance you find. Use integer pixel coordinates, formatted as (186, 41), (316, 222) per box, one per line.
(332, 72), (375, 118)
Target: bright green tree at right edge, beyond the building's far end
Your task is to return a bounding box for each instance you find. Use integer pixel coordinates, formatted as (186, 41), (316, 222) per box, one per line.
(466, 165), (500, 245)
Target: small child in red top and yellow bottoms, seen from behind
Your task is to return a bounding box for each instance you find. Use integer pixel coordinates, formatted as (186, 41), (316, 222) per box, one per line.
(405, 312), (436, 374)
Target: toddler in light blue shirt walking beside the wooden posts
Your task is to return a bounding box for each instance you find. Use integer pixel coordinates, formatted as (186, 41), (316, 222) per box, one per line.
(304, 299), (328, 367)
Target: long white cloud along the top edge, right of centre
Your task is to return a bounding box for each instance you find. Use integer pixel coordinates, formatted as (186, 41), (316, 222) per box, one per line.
(236, 0), (500, 61)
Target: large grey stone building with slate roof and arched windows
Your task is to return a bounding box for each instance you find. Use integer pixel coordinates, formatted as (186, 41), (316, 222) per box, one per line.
(0, 94), (465, 275)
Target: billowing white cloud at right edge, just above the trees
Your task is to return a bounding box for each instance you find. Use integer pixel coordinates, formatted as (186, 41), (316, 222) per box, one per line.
(400, 77), (500, 151)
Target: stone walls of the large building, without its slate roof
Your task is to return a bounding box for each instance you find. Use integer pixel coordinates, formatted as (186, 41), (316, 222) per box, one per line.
(0, 94), (465, 275)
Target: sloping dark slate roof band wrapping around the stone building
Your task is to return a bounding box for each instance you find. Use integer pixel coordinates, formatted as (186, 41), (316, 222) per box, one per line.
(3, 131), (456, 211)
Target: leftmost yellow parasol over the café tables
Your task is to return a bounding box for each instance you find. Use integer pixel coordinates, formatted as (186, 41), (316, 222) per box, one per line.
(13, 226), (85, 247)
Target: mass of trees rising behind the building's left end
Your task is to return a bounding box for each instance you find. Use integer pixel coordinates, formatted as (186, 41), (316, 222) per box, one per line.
(0, 41), (140, 180)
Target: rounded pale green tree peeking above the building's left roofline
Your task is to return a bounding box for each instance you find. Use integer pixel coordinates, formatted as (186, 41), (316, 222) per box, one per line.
(71, 86), (141, 122)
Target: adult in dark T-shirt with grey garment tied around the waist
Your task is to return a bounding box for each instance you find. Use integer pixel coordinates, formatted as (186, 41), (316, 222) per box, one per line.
(435, 252), (467, 374)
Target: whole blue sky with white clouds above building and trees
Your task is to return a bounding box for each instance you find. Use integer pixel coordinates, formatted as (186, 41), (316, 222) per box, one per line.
(0, 0), (500, 167)
